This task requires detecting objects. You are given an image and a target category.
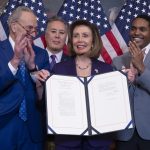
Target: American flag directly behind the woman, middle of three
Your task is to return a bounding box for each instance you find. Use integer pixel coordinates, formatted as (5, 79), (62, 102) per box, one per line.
(58, 0), (123, 63)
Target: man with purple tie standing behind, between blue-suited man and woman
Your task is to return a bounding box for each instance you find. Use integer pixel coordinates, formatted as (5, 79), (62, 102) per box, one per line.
(45, 16), (69, 70)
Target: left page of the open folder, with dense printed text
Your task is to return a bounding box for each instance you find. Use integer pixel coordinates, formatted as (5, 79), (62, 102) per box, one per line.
(46, 75), (87, 135)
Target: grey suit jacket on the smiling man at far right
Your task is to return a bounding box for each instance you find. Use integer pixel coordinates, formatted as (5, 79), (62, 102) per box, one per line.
(113, 51), (150, 141)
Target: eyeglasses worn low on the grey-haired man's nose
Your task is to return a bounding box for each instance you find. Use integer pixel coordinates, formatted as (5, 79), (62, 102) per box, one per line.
(17, 21), (38, 38)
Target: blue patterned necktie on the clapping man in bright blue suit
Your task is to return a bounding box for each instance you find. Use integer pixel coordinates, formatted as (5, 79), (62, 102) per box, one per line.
(19, 60), (27, 121)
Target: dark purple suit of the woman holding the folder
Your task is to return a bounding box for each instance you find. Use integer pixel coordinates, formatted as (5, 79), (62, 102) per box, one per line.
(52, 58), (113, 147)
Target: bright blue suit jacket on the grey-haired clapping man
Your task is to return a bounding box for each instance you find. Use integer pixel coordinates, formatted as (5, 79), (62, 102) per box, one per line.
(0, 40), (49, 142)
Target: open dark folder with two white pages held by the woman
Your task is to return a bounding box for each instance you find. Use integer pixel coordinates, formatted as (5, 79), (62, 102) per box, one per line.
(46, 71), (132, 135)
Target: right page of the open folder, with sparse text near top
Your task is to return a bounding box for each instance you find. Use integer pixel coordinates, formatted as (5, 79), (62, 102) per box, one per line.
(88, 71), (131, 133)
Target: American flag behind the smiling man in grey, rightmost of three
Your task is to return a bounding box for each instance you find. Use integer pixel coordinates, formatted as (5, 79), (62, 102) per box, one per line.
(112, 0), (150, 50)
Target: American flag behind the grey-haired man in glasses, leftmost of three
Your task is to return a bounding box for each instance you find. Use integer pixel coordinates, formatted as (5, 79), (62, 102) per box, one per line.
(0, 0), (47, 47)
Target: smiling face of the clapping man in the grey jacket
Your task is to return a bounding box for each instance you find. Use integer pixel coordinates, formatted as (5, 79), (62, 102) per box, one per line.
(130, 18), (150, 49)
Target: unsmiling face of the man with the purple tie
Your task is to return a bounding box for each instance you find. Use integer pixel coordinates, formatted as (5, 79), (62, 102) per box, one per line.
(45, 21), (67, 53)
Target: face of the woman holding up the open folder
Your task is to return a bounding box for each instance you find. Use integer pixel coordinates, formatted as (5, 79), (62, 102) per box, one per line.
(72, 25), (93, 55)
